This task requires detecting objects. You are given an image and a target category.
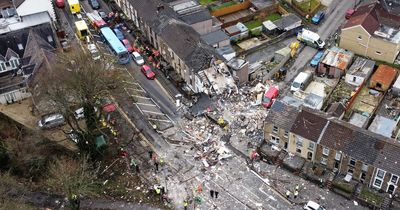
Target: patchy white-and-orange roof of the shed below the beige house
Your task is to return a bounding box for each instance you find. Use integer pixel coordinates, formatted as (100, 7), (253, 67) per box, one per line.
(321, 47), (354, 71)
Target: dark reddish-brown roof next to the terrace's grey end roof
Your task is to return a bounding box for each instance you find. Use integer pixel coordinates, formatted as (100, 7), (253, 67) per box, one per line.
(290, 107), (328, 142)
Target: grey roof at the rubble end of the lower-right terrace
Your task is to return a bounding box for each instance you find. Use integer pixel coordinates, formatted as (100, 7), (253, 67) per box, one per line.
(265, 101), (299, 130)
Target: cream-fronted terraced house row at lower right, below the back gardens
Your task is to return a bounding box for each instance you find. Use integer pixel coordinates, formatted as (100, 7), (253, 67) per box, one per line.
(264, 102), (400, 194)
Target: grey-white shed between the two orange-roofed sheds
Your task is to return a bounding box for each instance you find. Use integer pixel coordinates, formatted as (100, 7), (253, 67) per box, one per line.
(345, 57), (375, 86)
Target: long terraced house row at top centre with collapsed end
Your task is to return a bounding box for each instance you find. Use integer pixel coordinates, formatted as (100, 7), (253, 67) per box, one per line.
(112, 0), (218, 93)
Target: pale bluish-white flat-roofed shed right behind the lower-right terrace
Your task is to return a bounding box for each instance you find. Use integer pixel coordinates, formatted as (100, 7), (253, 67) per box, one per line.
(368, 115), (397, 138)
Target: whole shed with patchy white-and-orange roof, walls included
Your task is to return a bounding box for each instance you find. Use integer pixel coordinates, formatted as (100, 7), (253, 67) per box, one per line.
(317, 47), (354, 78)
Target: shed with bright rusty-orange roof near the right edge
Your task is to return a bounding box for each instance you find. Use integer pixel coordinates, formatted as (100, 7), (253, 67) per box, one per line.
(369, 64), (397, 92)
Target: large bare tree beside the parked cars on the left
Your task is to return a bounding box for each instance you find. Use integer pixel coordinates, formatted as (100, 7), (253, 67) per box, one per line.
(42, 53), (118, 155)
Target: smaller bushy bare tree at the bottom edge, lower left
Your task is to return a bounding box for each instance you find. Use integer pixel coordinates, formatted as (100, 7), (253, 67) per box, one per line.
(47, 156), (101, 209)
